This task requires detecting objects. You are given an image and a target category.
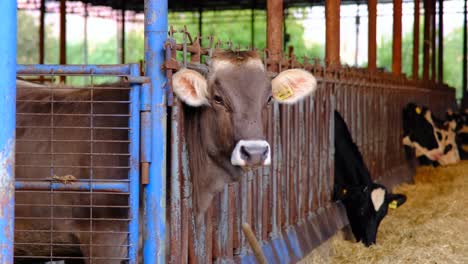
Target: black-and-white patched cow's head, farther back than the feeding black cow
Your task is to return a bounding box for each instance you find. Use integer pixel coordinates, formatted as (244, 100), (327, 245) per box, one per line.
(403, 103), (444, 165)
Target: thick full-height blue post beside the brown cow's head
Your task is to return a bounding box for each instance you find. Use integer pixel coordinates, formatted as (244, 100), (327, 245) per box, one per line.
(142, 0), (168, 264)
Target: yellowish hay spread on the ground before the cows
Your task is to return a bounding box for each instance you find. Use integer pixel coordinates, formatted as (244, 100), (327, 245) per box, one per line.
(301, 161), (468, 264)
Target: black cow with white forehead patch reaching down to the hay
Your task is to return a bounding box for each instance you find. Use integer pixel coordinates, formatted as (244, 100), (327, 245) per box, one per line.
(334, 111), (406, 246)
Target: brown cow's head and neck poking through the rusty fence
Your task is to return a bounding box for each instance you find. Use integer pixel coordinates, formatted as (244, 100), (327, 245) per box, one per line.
(173, 51), (316, 221)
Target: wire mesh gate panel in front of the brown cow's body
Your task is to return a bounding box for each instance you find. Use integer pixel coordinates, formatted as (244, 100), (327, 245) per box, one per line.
(15, 65), (139, 263)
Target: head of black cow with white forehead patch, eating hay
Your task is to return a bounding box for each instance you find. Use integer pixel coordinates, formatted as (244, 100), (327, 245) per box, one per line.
(336, 183), (406, 246)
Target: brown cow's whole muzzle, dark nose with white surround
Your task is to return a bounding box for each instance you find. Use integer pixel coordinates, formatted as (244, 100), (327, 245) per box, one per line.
(231, 140), (271, 166)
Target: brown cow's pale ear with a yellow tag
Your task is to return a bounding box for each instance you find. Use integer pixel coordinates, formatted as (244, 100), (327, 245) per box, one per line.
(271, 69), (317, 104)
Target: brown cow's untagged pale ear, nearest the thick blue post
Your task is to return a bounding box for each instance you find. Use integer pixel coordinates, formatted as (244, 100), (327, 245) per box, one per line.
(172, 69), (208, 107)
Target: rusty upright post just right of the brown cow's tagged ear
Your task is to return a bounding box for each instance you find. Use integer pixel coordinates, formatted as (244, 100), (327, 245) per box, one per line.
(325, 0), (341, 66)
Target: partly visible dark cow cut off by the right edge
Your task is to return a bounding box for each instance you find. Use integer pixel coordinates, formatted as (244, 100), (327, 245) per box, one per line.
(446, 109), (468, 160)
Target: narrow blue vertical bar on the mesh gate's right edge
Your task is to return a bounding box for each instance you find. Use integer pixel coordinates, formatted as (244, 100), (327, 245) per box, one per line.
(128, 64), (141, 264)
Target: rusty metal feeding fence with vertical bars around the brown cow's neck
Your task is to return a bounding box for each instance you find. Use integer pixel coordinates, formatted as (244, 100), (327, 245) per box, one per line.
(166, 30), (455, 263)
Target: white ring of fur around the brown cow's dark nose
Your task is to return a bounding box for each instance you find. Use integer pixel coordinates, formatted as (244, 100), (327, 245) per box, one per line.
(231, 140), (271, 166)
